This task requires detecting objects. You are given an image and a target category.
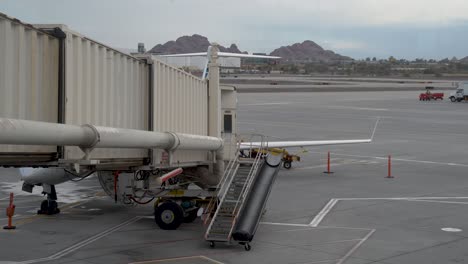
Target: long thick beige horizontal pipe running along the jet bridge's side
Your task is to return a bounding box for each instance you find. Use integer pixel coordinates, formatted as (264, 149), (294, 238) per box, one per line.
(0, 118), (223, 151)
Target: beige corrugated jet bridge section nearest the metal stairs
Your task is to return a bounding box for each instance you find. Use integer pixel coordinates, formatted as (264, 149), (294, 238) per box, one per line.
(153, 57), (208, 164)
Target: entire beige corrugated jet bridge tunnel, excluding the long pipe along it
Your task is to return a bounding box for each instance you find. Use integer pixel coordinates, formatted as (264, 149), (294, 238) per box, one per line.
(0, 13), (235, 167)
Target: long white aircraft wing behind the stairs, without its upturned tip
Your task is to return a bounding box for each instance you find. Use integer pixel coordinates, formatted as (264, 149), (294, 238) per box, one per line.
(240, 139), (372, 150)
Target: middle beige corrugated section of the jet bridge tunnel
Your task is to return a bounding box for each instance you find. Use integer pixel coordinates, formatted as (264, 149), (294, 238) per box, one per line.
(62, 26), (149, 159)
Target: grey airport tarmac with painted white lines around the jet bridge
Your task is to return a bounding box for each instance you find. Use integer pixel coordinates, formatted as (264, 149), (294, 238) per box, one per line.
(0, 91), (468, 264)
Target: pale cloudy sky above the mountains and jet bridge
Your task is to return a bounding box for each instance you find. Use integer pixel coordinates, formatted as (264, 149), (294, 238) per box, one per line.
(0, 0), (468, 59)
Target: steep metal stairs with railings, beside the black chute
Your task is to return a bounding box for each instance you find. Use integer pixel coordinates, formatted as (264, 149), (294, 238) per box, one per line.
(205, 139), (264, 247)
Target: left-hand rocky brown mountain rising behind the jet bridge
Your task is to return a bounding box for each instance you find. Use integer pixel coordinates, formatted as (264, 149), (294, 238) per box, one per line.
(149, 34), (242, 54)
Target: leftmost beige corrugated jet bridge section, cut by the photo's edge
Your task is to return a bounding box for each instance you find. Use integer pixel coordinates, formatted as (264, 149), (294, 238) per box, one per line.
(0, 13), (59, 154)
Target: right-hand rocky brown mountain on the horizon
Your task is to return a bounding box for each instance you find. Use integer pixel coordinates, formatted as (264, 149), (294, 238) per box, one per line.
(270, 40), (351, 62)
